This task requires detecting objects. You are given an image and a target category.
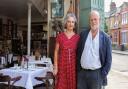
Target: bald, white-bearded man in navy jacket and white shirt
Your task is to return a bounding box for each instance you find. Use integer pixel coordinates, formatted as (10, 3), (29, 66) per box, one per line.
(77, 10), (112, 89)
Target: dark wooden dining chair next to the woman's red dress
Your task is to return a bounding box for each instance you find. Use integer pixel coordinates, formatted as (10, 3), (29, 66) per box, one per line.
(35, 72), (55, 89)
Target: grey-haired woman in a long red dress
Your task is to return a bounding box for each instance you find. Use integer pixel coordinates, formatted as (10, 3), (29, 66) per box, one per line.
(53, 13), (79, 89)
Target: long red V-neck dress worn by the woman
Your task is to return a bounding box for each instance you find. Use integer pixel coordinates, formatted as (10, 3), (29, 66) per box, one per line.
(55, 33), (79, 89)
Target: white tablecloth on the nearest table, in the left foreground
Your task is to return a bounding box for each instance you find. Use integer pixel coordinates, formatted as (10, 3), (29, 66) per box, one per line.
(0, 67), (48, 89)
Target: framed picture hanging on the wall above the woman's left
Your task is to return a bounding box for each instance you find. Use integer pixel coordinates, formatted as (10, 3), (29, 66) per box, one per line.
(51, 0), (64, 18)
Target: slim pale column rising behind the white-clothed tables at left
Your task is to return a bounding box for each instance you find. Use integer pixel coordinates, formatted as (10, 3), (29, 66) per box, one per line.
(27, 2), (32, 55)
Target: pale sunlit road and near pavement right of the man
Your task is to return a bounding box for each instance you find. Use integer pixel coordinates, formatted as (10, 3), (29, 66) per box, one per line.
(105, 53), (128, 89)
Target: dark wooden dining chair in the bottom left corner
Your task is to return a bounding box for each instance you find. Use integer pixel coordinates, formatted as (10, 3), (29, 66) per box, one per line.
(0, 74), (21, 89)
